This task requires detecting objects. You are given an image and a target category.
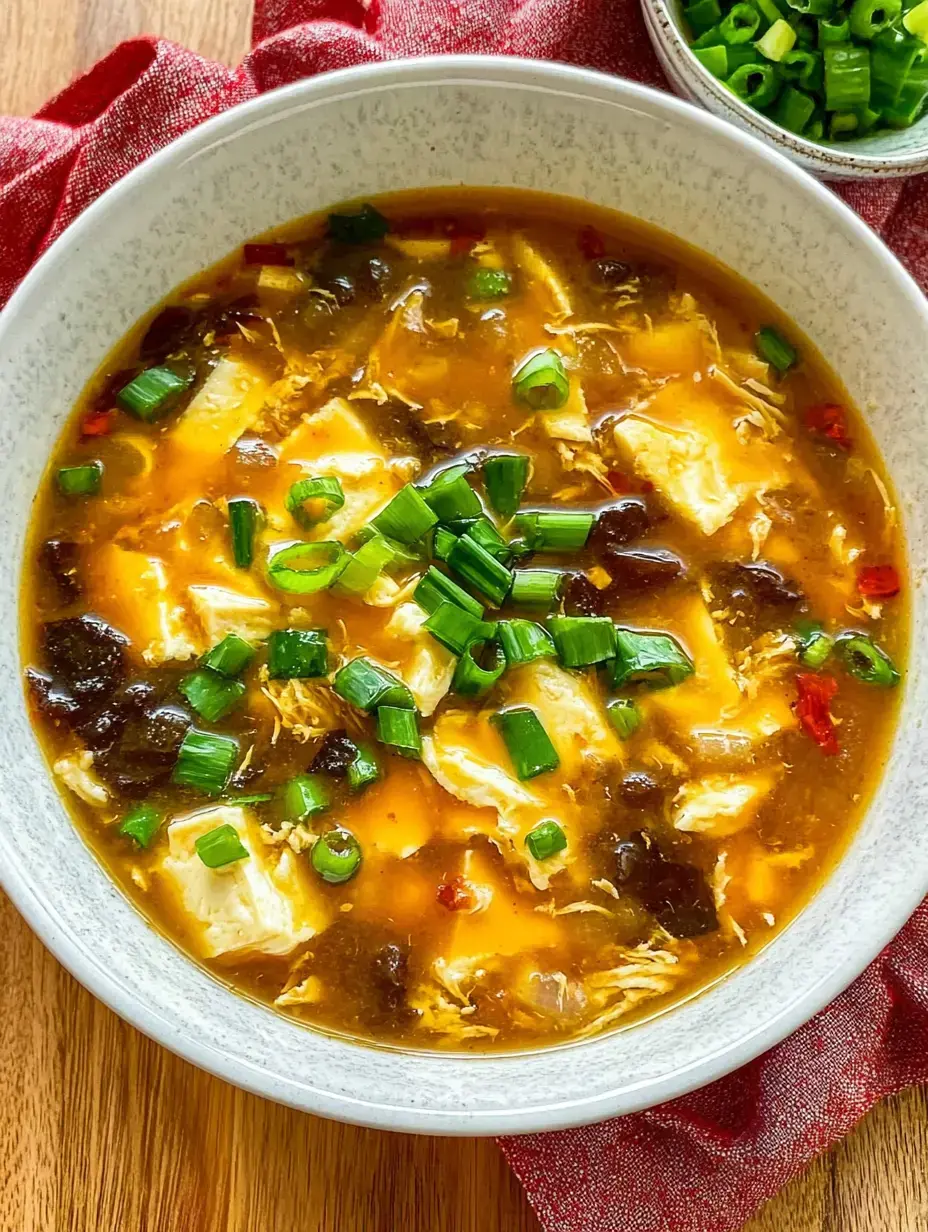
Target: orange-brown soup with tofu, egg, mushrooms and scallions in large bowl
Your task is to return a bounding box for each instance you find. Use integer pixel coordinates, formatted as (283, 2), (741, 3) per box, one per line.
(23, 191), (905, 1048)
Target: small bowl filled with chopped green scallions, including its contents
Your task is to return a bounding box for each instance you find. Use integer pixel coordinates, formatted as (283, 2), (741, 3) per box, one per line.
(642, 0), (928, 179)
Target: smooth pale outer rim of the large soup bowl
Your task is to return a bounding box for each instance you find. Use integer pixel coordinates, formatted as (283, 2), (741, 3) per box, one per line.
(0, 55), (928, 1136)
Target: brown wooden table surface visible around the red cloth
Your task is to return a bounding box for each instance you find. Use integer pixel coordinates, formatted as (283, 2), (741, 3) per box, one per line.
(0, 0), (928, 1232)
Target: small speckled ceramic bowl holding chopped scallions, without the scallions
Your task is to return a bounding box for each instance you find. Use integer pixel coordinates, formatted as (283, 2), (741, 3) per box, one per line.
(641, 0), (928, 180)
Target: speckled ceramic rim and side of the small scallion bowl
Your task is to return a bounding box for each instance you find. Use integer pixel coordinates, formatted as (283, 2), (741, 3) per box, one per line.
(641, 0), (928, 180)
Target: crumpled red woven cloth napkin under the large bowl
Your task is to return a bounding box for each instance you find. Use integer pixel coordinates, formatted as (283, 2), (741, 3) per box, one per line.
(0, 0), (928, 1232)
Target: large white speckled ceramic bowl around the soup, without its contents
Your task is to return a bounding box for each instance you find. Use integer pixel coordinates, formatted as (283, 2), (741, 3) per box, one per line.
(0, 57), (928, 1133)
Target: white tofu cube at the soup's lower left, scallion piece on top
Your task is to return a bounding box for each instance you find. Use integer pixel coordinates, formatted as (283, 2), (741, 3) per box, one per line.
(160, 806), (329, 958)
